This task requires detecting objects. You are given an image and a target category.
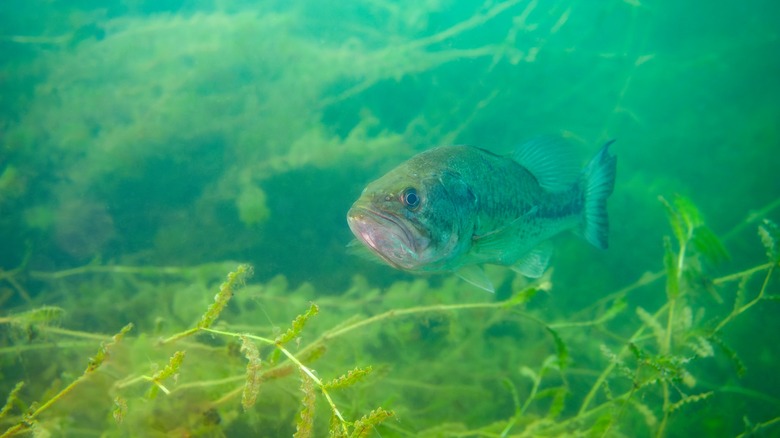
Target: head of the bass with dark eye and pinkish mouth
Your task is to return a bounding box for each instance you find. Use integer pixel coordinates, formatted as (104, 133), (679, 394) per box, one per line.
(347, 159), (471, 271)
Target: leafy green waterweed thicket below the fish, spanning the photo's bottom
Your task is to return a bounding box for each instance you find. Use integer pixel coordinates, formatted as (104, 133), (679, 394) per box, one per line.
(0, 199), (780, 437)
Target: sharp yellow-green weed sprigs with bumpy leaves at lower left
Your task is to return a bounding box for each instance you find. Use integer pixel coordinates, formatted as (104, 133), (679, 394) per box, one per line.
(0, 265), (393, 437)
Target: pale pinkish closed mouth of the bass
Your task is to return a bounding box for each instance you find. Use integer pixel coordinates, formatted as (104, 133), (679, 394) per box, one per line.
(347, 206), (418, 270)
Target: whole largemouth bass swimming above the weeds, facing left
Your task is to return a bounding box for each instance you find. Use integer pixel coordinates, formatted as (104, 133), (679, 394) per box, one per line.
(347, 137), (617, 292)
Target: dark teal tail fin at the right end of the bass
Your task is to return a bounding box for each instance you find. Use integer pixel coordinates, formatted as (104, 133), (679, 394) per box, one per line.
(582, 140), (617, 249)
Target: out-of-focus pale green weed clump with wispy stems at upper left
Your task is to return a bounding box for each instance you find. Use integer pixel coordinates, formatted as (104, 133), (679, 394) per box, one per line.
(0, 1), (536, 224)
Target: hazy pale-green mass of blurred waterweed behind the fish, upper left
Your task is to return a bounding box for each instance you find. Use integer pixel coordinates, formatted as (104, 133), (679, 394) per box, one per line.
(0, 0), (596, 274)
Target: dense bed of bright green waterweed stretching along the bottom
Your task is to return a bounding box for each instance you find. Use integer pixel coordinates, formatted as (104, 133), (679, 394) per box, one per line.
(0, 197), (780, 437)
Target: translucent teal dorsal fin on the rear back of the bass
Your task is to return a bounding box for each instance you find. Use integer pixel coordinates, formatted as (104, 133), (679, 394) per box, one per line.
(511, 137), (581, 192)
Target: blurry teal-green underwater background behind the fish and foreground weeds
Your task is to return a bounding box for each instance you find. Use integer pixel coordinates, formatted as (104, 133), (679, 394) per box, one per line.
(0, 0), (780, 436)
